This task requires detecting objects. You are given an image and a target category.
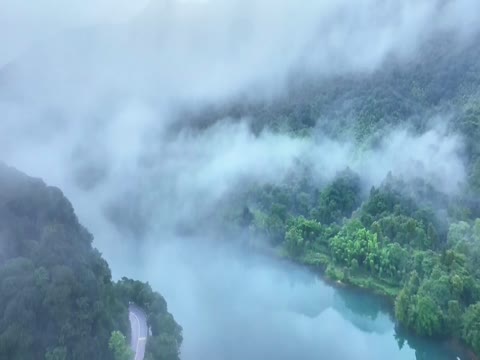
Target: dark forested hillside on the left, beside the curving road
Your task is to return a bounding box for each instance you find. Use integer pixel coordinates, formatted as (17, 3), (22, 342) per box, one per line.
(0, 165), (182, 360)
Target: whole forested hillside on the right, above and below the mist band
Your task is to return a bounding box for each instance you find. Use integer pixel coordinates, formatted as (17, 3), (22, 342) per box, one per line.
(206, 38), (480, 354)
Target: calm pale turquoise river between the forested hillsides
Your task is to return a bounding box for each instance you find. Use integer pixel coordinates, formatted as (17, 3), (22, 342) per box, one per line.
(129, 239), (464, 360)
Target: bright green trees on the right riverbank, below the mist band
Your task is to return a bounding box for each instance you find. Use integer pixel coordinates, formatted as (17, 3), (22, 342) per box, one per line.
(237, 166), (480, 354)
